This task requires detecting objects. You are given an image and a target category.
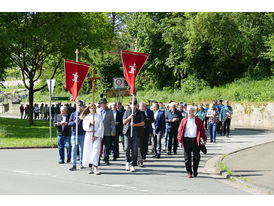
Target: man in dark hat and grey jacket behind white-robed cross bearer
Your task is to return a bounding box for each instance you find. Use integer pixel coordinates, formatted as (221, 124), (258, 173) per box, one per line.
(99, 98), (116, 165)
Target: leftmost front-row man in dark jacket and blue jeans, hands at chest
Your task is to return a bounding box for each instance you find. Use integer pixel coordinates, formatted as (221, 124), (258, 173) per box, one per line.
(54, 106), (71, 164)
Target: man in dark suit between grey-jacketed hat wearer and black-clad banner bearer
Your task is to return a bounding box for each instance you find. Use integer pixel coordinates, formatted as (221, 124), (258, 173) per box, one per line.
(111, 102), (123, 161)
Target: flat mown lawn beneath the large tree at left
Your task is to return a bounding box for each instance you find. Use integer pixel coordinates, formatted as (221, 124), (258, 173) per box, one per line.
(0, 118), (57, 148)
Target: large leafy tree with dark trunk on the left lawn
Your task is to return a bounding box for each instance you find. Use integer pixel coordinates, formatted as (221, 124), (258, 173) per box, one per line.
(0, 13), (113, 125)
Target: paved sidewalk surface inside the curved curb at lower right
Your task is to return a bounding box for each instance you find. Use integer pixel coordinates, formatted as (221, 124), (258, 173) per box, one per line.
(224, 142), (274, 195)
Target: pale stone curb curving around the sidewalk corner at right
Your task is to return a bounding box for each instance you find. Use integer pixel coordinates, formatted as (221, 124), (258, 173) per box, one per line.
(204, 141), (274, 195)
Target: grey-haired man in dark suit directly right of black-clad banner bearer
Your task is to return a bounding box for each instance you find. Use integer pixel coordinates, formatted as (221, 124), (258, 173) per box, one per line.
(140, 102), (154, 163)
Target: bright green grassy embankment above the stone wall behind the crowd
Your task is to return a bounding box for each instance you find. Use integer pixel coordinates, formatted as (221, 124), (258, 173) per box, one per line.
(35, 77), (274, 103)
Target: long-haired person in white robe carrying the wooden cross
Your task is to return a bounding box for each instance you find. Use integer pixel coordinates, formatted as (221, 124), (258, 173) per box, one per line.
(80, 104), (104, 175)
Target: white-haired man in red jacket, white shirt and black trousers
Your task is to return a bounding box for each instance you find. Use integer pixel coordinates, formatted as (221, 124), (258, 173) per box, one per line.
(177, 105), (207, 178)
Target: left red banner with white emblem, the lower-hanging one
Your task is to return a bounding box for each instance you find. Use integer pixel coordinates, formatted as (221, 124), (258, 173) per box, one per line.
(64, 59), (90, 101)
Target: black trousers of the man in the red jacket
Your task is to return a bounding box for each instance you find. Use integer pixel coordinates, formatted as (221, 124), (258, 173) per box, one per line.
(183, 138), (200, 175)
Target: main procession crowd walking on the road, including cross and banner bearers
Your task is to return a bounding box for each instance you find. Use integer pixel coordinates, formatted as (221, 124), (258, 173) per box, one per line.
(52, 98), (232, 177)
